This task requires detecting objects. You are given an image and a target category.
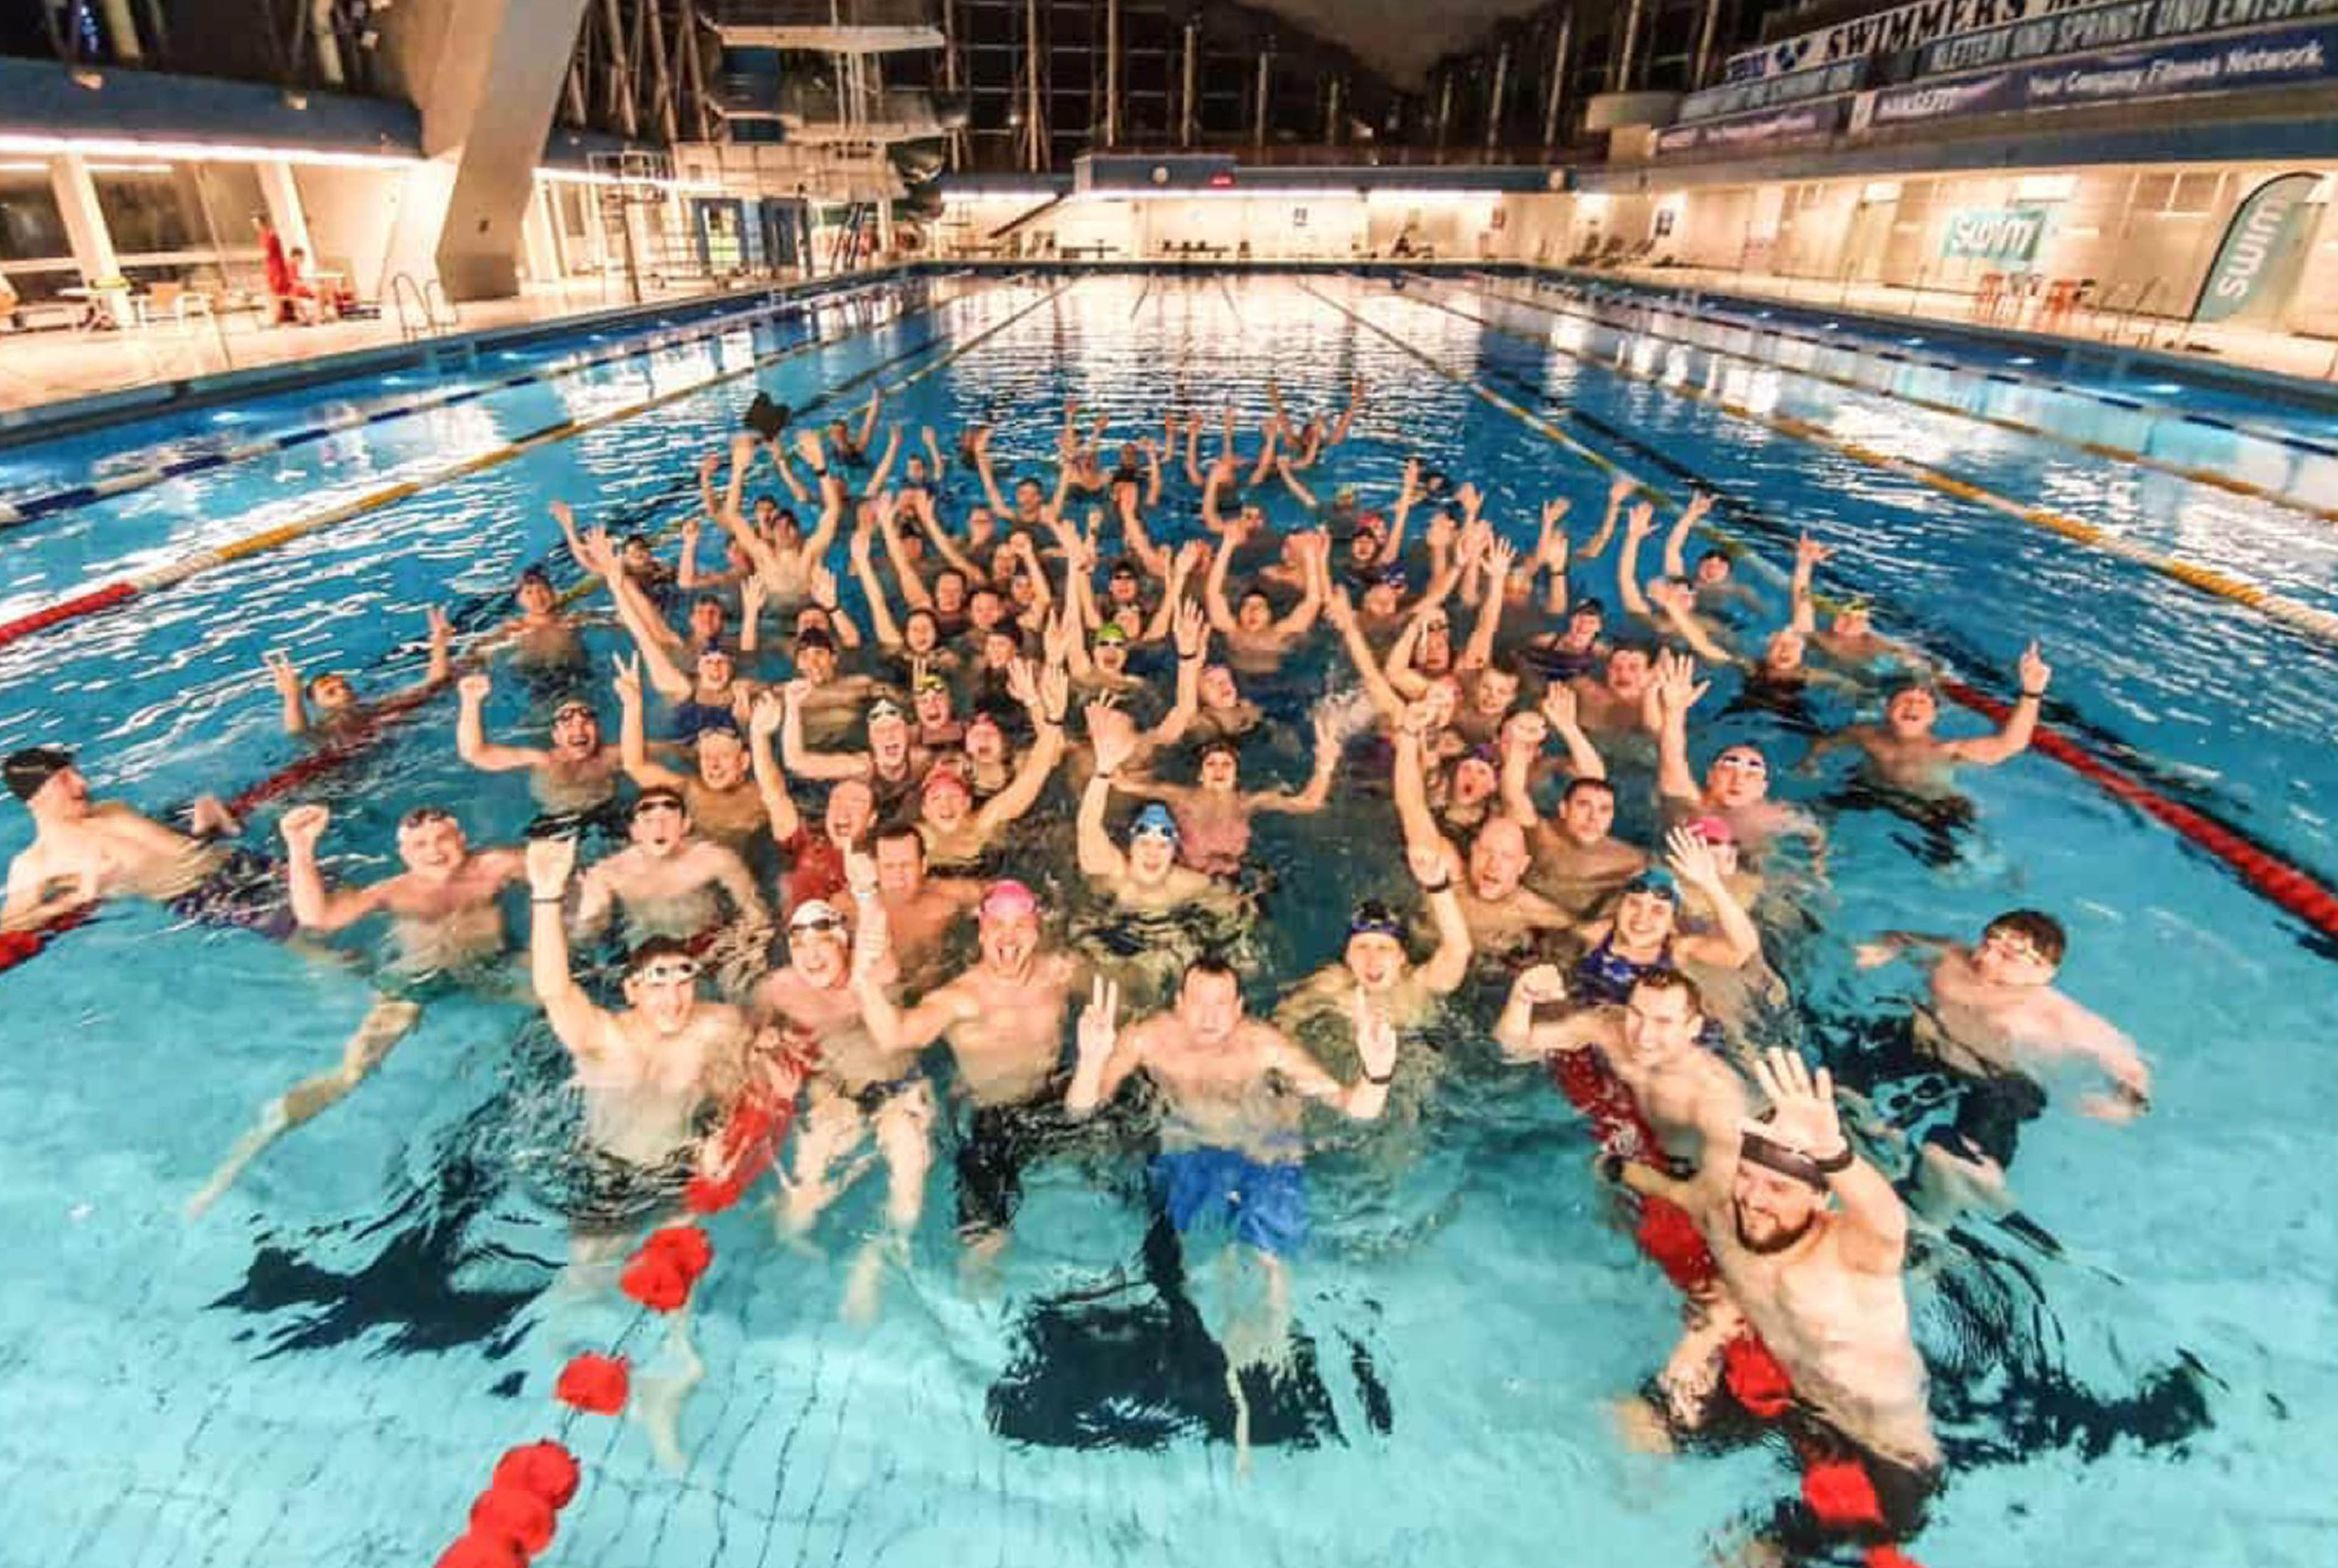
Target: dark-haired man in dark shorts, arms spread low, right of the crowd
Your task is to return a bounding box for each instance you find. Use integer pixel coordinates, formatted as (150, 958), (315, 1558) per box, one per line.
(1854, 909), (2151, 1211)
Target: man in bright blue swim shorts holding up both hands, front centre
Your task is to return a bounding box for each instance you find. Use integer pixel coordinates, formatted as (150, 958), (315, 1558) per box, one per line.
(1064, 958), (1395, 1365)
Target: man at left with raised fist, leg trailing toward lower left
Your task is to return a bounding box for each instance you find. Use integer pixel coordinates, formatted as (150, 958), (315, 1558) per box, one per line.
(187, 806), (526, 1217)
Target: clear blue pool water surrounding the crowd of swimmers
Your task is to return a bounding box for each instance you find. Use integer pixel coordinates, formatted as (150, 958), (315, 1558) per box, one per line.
(0, 276), (2338, 1568)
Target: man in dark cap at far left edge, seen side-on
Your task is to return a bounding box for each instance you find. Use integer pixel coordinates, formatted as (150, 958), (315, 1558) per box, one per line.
(0, 746), (297, 939)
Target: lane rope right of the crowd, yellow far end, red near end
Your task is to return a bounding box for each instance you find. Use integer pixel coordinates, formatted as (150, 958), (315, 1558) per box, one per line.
(1300, 283), (2338, 942)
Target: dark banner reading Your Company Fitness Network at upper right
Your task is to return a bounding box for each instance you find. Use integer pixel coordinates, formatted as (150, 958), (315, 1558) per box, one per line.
(1870, 23), (2338, 126)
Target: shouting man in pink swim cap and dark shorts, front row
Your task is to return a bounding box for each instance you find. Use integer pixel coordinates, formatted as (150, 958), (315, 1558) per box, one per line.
(863, 881), (1078, 1269)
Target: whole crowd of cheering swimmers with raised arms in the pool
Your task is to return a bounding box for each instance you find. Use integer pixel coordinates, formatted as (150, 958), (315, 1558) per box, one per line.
(0, 383), (2149, 1549)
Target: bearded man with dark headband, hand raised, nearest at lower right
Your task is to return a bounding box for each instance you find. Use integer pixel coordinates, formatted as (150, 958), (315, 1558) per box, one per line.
(1611, 1052), (1940, 1556)
